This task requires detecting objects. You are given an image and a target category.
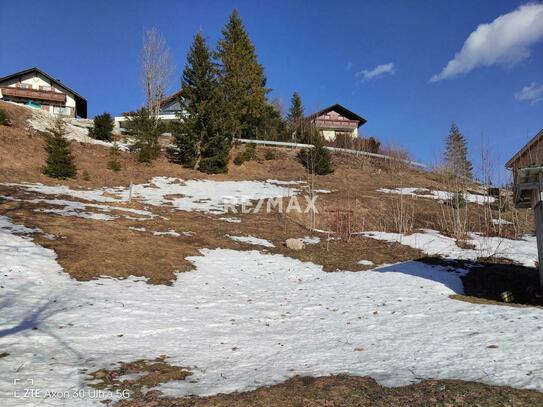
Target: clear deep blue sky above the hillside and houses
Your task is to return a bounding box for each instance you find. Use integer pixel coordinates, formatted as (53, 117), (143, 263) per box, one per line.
(0, 0), (543, 180)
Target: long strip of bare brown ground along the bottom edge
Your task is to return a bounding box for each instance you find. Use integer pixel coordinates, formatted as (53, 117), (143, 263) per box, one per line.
(112, 376), (543, 407)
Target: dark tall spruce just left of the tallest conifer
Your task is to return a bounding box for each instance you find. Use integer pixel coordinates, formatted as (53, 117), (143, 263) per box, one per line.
(170, 33), (231, 173)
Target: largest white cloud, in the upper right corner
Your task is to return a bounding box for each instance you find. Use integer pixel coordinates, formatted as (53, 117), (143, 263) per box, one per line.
(430, 3), (543, 82)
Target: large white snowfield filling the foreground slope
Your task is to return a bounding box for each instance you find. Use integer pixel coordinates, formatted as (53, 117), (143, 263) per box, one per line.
(0, 217), (543, 407)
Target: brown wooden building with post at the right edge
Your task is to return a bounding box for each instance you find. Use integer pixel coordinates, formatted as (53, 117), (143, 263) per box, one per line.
(506, 130), (543, 289)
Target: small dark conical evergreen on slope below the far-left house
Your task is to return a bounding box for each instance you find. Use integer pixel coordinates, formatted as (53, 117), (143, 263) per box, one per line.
(43, 118), (77, 179)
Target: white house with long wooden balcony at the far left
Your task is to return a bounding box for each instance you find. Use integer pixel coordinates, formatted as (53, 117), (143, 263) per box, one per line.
(0, 67), (87, 118)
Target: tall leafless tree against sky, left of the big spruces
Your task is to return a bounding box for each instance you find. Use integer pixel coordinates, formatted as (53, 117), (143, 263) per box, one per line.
(141, 28), (174, 121)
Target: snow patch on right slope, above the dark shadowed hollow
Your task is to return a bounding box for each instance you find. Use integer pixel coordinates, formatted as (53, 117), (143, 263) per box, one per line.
(359, 229), (537, 267)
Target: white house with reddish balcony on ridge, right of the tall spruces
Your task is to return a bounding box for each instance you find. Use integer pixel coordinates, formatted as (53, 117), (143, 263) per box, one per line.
(307, 103), (366, 141)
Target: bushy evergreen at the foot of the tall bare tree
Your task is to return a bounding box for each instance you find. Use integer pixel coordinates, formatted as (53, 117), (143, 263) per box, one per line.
(125, 107), (163, 163)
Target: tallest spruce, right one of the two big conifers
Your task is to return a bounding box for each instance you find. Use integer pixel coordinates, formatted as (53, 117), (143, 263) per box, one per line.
(216, 10), (269, 138)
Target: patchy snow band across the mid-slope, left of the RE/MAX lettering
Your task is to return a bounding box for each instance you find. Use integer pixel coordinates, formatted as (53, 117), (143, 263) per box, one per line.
(2, 177), (300, 214)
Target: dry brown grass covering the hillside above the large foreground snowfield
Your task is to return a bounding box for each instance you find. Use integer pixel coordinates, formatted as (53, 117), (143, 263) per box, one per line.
(0, 103), (530, 284)
